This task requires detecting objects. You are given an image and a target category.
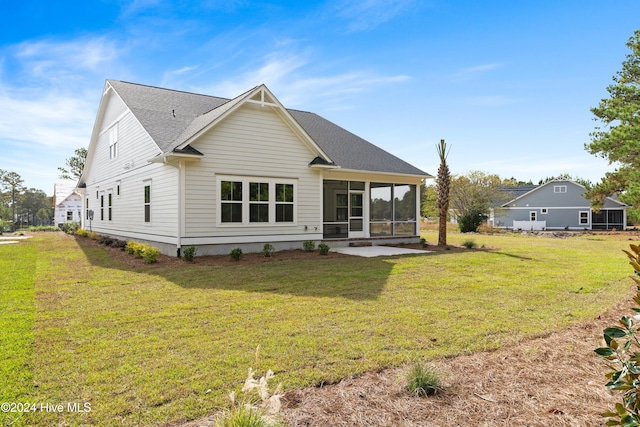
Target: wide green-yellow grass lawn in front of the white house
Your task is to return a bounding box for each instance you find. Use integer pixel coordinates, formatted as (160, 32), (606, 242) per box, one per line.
(0, 234), (632, 426)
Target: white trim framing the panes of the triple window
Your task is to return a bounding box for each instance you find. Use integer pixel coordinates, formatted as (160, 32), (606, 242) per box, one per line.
(216, 175), (298, 228)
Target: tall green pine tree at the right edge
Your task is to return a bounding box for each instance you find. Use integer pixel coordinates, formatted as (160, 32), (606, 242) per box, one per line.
(585, 30), (640, 209)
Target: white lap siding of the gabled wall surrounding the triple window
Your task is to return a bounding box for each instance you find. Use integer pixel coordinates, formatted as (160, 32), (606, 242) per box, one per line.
(185, 105), (321, 237)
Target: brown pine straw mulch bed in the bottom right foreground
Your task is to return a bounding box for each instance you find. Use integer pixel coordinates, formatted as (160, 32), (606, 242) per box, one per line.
(283, 298), (633, 427)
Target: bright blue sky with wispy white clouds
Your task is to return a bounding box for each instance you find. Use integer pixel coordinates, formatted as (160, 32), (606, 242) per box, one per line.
(0, 0), (640, 194)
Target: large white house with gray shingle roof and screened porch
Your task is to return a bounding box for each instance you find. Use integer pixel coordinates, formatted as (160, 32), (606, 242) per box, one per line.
(78, 80), (430, 255)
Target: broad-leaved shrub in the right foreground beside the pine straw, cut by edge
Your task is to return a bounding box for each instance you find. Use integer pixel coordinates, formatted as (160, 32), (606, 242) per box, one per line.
(595, 244), (640, 426)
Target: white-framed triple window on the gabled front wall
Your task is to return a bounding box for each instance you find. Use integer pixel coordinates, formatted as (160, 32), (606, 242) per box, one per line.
(218, 176), (296, 225)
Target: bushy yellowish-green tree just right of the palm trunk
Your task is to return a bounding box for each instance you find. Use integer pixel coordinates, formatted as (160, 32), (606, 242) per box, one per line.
(451, 171), (510, 233)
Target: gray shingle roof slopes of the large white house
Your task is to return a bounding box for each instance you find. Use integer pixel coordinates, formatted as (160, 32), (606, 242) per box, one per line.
(108, 80), (429, 176)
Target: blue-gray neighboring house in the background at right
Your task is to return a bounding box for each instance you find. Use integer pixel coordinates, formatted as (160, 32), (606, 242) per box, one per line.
(489, 179), (628, 234)
